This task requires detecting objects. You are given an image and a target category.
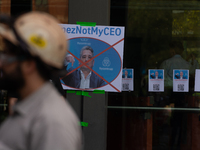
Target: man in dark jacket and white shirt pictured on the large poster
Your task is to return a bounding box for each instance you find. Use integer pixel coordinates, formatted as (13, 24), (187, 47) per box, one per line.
(62, 46), (105, 89)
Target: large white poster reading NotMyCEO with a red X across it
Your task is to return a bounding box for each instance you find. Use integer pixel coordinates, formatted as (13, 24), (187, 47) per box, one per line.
(61, 24), (124, 92)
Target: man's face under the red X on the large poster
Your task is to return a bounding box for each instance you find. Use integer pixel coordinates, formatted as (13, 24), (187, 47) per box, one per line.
(79, 50), (94, 70)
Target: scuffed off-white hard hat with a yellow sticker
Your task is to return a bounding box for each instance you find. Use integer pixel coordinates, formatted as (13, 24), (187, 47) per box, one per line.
(0, 11), (67, 68)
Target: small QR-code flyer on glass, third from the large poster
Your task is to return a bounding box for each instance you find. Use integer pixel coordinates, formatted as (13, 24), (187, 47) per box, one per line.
(173, 70), (189, 92)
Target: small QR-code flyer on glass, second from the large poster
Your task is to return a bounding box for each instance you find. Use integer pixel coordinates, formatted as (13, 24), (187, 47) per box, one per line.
(149, 69), (164, 92)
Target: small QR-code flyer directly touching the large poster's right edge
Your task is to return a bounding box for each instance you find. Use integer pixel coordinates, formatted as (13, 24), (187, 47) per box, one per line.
(122, 69), (134, 91)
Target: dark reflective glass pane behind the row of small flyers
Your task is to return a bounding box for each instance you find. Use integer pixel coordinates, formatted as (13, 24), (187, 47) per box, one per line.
(107, 0), (200, 150)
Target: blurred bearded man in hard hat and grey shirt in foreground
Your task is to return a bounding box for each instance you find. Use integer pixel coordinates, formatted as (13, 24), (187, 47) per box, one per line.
(0, 12), (81, 150)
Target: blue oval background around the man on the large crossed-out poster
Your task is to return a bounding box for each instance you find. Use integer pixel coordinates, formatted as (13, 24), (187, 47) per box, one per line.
(61, 37), (122, 84)
